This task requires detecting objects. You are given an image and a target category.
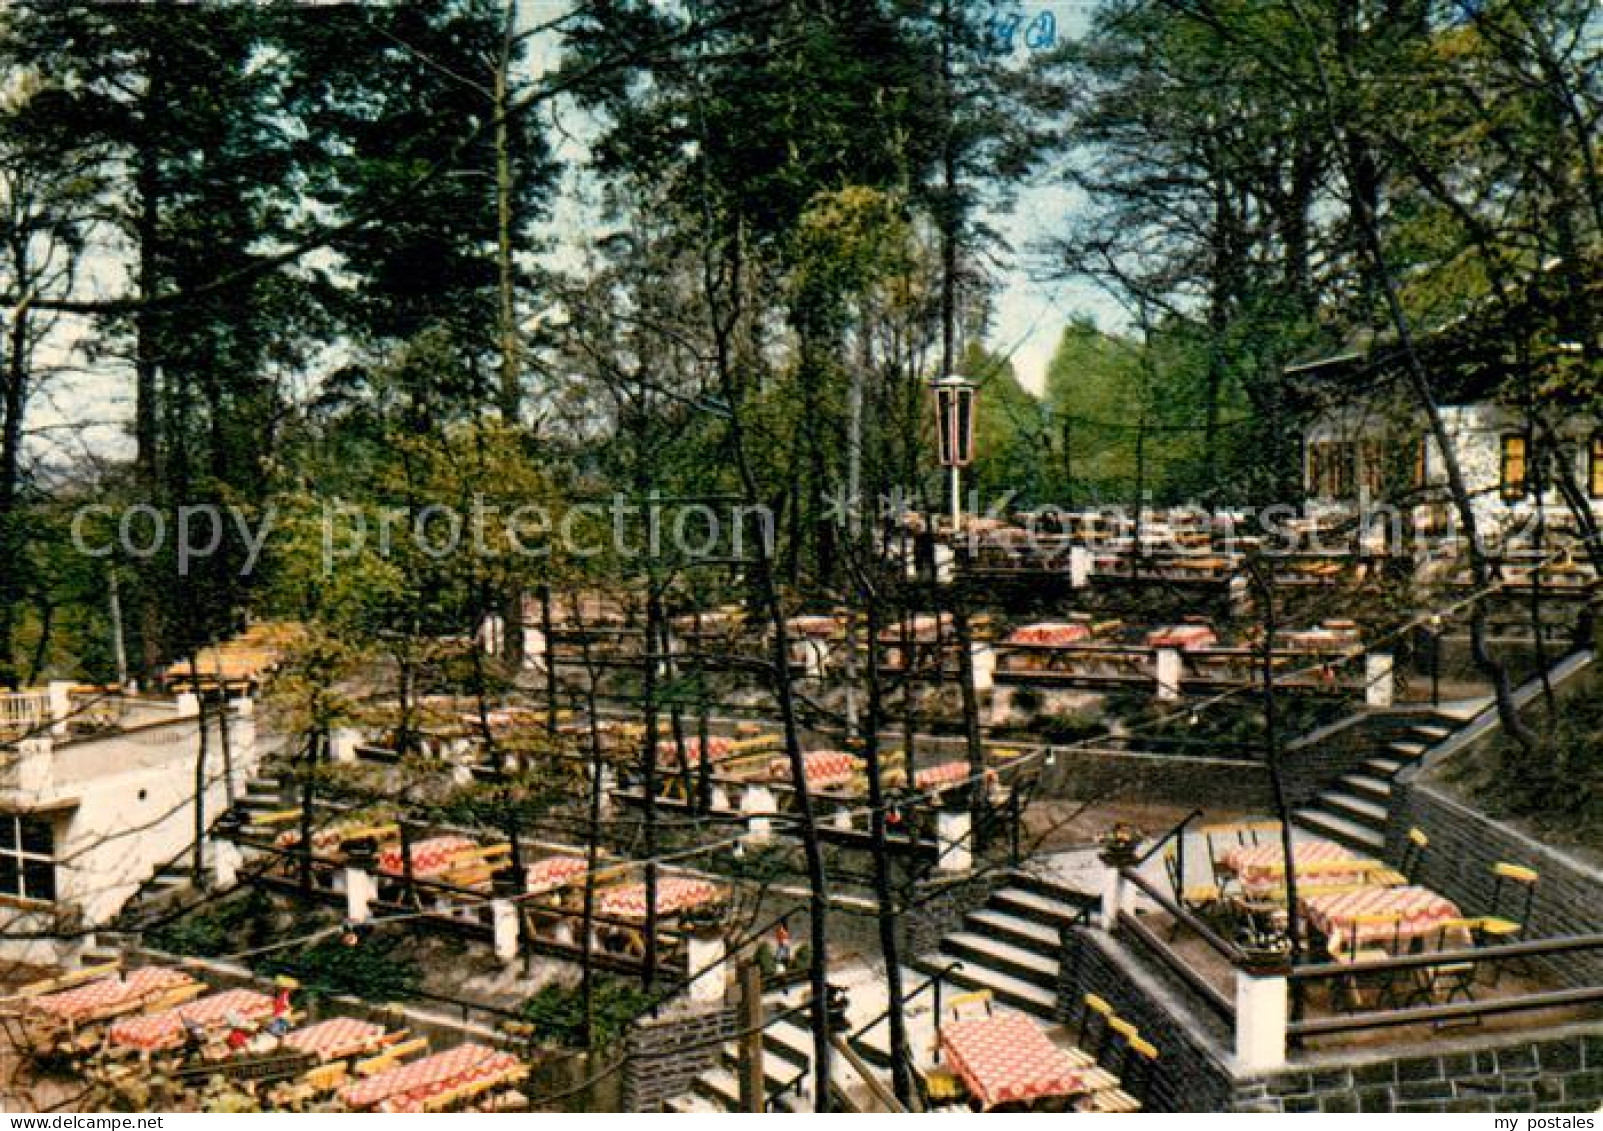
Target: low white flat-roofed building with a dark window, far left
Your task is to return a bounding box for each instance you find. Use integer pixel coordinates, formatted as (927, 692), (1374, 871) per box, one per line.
(0, 684), (258, 964)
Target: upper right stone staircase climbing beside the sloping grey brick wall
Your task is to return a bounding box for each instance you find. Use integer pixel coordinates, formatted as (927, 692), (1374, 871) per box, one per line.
(1292, 711), (1465, 855)
